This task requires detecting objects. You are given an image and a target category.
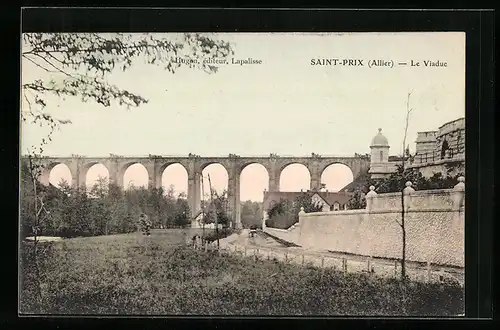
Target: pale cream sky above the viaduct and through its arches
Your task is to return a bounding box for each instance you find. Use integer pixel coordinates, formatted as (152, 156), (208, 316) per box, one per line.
(21, 33), (465, 201)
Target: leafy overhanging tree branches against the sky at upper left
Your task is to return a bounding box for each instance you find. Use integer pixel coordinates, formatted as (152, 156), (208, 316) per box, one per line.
(21, 33), (234, 143)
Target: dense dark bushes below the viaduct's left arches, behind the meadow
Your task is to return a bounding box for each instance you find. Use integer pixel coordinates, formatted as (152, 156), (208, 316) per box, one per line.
(20, 170), (190, 238)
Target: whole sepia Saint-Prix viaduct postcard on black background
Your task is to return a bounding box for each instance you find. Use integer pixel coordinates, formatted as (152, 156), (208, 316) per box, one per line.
(18, 32), (466, 317)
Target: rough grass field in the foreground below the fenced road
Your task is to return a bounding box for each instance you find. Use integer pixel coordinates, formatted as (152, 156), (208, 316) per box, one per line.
(20, 230), (464, 316)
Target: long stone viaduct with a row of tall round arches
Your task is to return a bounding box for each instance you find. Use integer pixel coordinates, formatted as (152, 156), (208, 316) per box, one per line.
(31, 153), (370, 227)
